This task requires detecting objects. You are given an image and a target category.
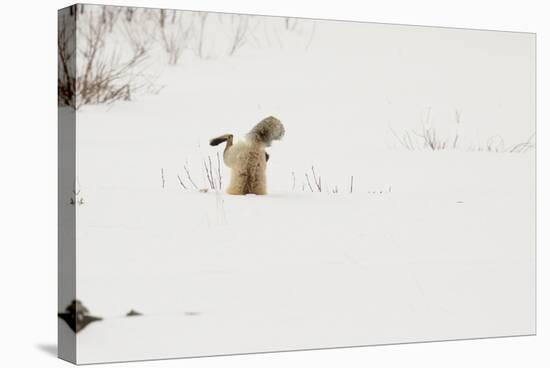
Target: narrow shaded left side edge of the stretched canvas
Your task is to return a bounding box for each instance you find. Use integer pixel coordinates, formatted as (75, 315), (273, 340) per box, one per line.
(57, 5), (76, 363)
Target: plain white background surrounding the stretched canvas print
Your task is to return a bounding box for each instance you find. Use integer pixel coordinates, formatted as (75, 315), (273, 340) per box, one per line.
(0, 0), (550, 367)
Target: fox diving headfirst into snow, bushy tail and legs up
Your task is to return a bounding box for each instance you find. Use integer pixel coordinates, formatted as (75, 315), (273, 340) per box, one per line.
(210, 116), (285, 195)
